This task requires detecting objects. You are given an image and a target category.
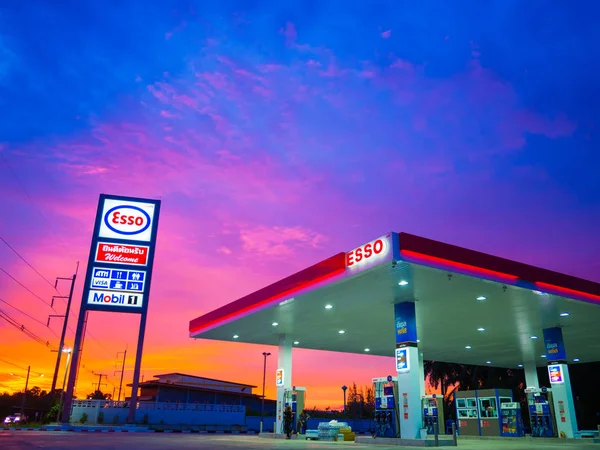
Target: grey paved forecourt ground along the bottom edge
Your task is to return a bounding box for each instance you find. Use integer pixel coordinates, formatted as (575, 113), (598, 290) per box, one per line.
(0, 431), (600, 450)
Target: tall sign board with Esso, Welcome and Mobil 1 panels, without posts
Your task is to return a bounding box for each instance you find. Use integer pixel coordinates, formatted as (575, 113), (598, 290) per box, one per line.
(82, 194), (160, 314)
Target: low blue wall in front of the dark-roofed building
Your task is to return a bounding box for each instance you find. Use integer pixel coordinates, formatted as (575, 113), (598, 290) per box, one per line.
(71, 400), (246, 426)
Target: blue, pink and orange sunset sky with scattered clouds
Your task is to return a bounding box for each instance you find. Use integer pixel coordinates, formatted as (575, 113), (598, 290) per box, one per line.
(0, 0), (600, 406)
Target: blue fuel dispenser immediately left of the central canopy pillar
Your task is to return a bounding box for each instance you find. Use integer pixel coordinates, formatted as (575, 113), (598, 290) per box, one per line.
(373, 375), (400, 437)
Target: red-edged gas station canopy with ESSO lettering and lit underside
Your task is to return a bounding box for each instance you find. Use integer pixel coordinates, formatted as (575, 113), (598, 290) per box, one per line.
(189, 233), (600, 368)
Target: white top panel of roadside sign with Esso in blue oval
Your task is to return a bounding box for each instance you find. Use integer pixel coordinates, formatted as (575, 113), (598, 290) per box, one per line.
(98, 199), (154, 242)
